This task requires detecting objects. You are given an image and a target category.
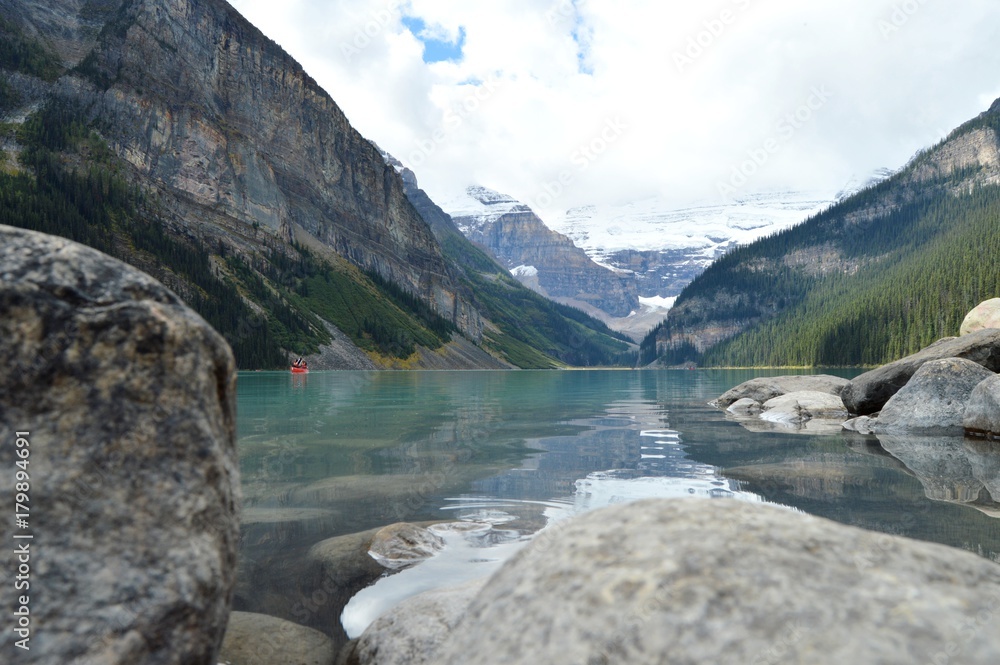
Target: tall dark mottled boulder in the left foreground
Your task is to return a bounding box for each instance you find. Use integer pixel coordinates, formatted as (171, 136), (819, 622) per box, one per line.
(0, 226), (239, 665)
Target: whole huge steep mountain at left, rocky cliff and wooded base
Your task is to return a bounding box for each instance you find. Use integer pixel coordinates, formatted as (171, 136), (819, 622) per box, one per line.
(0, 0), (624, 368)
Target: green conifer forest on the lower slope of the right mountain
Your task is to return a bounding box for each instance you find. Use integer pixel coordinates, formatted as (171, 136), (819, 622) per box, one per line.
(704, 187), (1000, 366)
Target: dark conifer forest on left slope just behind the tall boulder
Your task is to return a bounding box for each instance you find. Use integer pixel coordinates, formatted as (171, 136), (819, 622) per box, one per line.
(0, 104), (285, 367)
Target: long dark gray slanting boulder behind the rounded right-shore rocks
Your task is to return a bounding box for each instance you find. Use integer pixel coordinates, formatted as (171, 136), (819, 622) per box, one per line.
(840, 328), (1000, 416)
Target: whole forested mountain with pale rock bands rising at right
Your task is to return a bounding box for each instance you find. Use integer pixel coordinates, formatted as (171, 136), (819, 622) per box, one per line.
(642, 100), (1000, 366)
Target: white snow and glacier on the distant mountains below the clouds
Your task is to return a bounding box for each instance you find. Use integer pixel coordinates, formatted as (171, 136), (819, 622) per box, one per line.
(442, 170), (892, 338)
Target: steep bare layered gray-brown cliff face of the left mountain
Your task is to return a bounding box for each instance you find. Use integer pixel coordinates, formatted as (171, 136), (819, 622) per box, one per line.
(8, 0), (482, 340)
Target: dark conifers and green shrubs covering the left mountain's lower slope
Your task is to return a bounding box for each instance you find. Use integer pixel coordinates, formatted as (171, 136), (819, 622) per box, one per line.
(0, 99), (454, 369)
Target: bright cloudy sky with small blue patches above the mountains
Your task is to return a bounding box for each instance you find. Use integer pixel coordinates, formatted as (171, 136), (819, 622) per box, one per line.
(231, 0), (1000, 213)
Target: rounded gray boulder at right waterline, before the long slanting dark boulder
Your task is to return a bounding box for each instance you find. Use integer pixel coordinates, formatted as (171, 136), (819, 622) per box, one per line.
(872, 358), (997, 434)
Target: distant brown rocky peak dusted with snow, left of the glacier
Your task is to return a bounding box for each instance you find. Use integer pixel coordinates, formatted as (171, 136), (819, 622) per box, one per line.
(444, 187), (639, 318)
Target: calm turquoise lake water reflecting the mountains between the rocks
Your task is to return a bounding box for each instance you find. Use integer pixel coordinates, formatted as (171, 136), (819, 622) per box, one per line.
(234, 370), (1000, 641)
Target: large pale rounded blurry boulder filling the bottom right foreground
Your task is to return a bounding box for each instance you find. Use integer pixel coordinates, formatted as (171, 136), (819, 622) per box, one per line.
(362, 500), (1000, 665)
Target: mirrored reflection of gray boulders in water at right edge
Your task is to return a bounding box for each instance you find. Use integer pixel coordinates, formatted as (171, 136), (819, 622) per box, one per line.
(878, 434), (1000, 517)
